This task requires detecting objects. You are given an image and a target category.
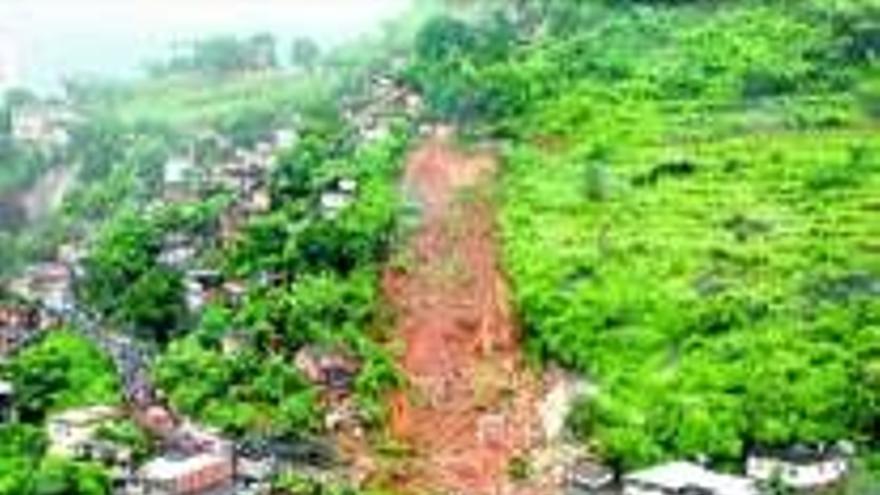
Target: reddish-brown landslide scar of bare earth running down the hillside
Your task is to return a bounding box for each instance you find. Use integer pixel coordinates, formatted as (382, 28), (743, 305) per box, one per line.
(384, 132), (545, 495)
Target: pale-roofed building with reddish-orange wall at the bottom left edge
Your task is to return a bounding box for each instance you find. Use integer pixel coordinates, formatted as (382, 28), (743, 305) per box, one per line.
(139, 453), (234, 495)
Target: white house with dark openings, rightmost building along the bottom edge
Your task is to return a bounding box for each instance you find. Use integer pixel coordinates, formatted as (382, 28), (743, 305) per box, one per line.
(746, 442), (854, 490)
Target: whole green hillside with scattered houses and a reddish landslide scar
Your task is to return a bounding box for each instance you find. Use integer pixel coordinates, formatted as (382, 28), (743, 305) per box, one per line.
(0, 0), (880, 495)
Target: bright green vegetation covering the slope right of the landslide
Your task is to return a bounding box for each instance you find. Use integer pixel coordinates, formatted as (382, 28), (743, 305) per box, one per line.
(410, 1), (880, 467)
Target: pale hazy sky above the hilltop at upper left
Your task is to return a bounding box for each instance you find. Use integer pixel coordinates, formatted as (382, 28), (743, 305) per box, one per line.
(0, 0), (409, 93)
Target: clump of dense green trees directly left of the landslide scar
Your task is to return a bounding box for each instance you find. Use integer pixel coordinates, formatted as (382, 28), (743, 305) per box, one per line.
(156, 124), (406, 436)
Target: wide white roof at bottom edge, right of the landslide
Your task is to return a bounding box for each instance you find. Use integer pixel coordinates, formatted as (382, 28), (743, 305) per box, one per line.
(623, 462), (759, 495)
